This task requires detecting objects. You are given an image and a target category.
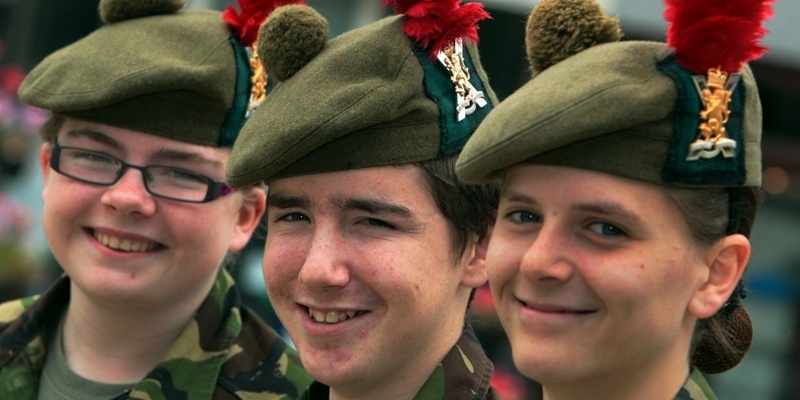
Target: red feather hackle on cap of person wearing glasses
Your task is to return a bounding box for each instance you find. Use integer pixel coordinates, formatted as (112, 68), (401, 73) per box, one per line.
(222, 0), (305, 46)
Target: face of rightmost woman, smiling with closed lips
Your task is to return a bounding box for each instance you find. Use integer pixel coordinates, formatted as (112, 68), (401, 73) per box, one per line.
(486, 165), (704, 385)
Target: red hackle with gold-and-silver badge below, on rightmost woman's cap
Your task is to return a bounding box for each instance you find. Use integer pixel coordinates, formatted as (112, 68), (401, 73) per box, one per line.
(664, 0), (774, 161)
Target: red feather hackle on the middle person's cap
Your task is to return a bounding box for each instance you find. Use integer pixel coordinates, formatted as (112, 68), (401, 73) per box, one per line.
(384, 0), (491, 59)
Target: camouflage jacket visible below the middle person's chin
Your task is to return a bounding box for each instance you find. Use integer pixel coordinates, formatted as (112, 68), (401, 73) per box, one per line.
(297, 325), (500, 400)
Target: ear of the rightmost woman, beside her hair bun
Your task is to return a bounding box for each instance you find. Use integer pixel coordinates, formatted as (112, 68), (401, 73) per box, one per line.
(689, 234), (750, 319)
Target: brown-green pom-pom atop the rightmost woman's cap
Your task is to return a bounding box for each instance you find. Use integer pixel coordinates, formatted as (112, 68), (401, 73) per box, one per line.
(525, 0), (622, 74)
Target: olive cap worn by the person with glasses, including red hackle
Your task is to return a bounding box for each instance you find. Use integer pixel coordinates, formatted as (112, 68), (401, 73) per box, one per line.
(19, 0), (296, 147)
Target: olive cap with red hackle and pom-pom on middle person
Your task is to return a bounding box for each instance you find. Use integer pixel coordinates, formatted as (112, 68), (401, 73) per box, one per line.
(226, 0), (497, 187)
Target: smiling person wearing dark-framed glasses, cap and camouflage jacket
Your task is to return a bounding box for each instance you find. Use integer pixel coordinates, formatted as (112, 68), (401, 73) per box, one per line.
(0, 0), (310, 400)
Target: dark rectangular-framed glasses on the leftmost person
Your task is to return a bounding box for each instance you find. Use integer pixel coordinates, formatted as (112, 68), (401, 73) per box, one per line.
(50, 141), (235, 203)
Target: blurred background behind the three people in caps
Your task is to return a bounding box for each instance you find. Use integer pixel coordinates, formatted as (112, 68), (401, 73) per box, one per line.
(0, 0), (800, 400)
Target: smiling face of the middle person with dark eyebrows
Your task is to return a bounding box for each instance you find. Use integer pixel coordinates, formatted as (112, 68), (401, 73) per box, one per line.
(264, 166), (482, 398)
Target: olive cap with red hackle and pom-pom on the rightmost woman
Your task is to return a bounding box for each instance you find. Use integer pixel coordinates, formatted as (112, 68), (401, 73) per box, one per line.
(456, 0), (771, 187)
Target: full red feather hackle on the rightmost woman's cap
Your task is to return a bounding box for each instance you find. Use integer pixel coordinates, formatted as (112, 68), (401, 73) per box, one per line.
(664, 0), (774, 75)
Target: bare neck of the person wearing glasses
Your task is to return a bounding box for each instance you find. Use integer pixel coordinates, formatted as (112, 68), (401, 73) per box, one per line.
(61, 284), (209, 383)
